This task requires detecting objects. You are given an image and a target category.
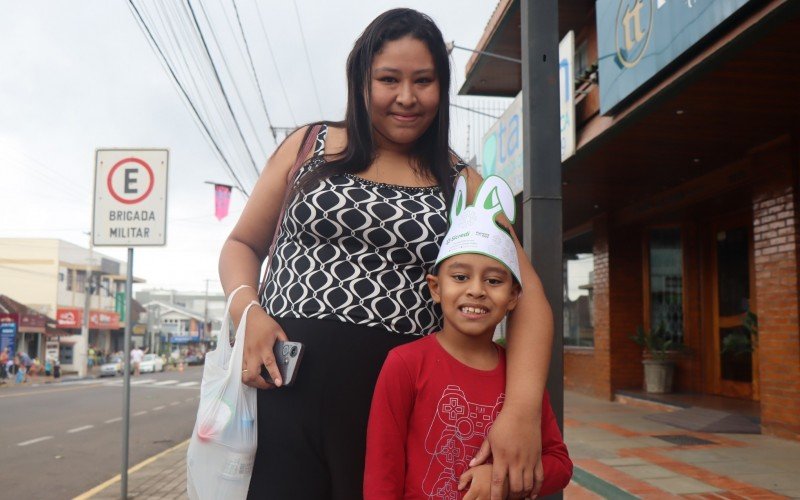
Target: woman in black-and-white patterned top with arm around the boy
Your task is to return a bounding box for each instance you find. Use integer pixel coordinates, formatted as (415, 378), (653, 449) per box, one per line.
(220, 9), (552, 499)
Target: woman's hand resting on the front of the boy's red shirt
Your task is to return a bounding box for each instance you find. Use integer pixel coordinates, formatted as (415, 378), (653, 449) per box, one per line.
(470, 408), (544, 500)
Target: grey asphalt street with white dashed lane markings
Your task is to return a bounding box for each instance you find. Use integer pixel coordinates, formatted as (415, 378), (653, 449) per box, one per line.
(0, 367), (202, 499)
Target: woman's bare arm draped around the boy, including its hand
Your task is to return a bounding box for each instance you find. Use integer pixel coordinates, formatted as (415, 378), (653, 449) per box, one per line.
(460, 168), (553, 499)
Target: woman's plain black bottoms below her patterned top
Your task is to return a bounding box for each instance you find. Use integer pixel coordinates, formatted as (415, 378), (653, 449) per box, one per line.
(248, 318), (419, 500)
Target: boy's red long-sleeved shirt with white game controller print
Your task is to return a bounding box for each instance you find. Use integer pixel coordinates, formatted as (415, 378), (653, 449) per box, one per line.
(364, 335), (572, 500)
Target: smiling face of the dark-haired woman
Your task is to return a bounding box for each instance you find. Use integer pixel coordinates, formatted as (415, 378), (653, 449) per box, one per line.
(369, 36), (439, 150)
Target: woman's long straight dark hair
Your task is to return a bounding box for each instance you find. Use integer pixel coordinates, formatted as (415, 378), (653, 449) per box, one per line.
(296, 9), (454, 205)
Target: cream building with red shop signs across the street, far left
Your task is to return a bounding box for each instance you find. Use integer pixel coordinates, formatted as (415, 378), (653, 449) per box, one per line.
(0, 238), (144, 374)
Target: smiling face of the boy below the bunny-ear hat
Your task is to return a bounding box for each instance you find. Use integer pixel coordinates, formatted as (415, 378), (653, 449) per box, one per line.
(427, 254), (520, 336)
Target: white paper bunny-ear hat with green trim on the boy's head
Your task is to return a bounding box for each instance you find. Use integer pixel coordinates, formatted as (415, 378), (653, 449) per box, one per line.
(435, 175), (522, 283)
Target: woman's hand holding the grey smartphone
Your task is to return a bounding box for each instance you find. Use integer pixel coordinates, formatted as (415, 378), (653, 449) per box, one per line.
(242, 307), (289, 389)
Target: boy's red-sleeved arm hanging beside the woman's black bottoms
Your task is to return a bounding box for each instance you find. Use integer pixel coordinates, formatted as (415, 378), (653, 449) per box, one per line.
(364, 352), (414, 500)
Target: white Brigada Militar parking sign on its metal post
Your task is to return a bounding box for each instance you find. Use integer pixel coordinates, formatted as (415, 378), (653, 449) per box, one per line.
(92, 149), (169, 498)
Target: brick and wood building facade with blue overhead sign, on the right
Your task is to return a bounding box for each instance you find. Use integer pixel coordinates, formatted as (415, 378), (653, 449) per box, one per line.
(461, 0), (800, 439)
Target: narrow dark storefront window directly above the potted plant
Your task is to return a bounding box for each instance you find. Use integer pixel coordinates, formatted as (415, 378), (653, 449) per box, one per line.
(650, 227), (683, 343)
